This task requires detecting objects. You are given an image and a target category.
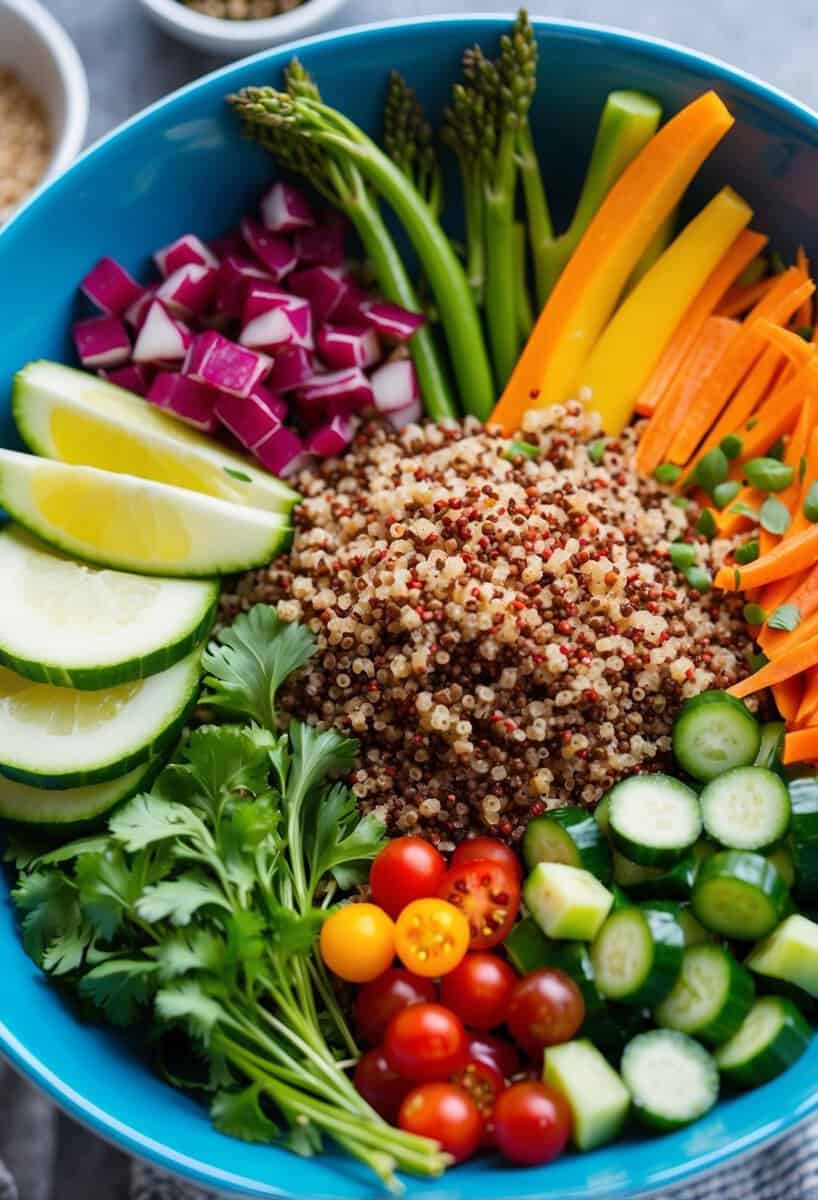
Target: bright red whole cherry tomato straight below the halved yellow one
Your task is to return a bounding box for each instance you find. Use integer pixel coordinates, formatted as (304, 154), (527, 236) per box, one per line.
(384, 1004), (467, 1084)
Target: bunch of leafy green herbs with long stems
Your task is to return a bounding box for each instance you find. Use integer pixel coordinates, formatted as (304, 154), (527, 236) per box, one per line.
(13, 605), (447, 1190)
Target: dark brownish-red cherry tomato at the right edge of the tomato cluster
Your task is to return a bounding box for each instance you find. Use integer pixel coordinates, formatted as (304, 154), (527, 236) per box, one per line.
(506, 967), (585, 1058)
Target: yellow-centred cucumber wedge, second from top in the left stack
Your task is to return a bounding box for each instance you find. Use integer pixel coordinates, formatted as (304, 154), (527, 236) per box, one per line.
(0, 449), (291, 578)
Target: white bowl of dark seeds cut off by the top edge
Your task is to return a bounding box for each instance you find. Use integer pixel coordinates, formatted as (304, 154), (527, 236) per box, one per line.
(139, 0), (345, 59)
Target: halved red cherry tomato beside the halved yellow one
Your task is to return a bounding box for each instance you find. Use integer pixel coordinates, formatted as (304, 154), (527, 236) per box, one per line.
(438, 859), (519, 950)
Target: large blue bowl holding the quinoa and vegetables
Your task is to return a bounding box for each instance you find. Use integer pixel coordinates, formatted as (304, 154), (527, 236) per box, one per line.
(0, 17), (818, 1200)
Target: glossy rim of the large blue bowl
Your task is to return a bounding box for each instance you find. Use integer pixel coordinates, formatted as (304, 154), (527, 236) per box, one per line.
(0, 11), (818, 1200)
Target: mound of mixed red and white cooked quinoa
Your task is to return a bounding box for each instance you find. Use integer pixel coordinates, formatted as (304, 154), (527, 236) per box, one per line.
(223, 404), (751, 848)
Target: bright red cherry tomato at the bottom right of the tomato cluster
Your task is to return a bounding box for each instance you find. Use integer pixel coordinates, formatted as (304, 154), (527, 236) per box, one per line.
(486, 1084), (572, 1166)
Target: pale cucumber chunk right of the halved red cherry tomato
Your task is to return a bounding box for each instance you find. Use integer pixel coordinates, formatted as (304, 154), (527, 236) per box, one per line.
(523, 863), (613, 942)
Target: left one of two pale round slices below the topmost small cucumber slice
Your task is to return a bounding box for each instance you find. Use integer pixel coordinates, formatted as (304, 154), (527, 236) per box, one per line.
(611, 775), (702, 866)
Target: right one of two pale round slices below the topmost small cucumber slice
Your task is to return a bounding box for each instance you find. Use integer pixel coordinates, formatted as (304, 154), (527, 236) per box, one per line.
(699, 767), (790, 851)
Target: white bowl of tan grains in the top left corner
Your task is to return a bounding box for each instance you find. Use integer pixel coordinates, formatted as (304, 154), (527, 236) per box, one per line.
(0, 0), (89, 210)
